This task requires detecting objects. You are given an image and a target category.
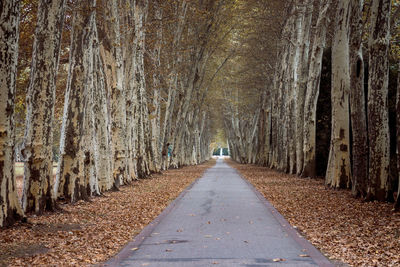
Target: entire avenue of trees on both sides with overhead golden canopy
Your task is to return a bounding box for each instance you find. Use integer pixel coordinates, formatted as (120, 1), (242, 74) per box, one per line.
(0, 0), (400, 227)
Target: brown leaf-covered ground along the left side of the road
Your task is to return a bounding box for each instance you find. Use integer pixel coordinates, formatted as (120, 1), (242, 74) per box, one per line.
(0, 159), (215, 266)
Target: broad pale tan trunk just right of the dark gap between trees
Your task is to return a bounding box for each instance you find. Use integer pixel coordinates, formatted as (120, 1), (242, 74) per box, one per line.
(325, 0), (351, 188)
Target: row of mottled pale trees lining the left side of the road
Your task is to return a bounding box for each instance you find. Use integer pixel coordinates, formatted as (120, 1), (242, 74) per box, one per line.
(0, 0), (225, 227)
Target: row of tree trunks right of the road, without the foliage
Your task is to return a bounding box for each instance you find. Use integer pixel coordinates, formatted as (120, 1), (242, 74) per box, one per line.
(225, 0), (400, 203)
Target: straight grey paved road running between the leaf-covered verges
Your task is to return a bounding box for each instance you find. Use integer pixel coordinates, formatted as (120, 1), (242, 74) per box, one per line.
(107, 159), (332, 267)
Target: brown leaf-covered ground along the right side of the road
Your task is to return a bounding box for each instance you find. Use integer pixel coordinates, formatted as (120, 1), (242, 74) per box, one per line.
(227, 160), (400, 266)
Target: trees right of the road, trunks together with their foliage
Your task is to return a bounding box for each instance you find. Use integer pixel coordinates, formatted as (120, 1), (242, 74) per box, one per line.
(221, 0), (400, 205)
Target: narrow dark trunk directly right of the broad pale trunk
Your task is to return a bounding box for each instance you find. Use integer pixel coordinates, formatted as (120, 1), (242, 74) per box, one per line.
(350, 0), (368, 197)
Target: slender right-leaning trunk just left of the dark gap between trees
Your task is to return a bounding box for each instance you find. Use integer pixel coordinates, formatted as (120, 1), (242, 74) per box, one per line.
(301, 0), (331, 180)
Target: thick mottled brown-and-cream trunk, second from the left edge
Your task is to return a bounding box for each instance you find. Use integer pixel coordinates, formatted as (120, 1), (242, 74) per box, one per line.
(22, 0), (65, 213)
